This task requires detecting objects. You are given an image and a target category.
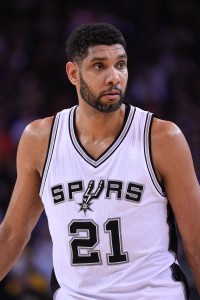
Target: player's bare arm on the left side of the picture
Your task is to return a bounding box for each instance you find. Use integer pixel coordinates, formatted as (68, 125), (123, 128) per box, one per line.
(0, 116), (50, 280)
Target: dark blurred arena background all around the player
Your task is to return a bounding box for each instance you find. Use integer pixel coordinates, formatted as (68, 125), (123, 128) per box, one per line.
(0, 0), (200, 300)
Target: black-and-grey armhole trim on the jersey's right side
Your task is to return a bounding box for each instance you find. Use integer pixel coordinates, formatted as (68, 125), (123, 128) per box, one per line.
(144, 112), (166, 197)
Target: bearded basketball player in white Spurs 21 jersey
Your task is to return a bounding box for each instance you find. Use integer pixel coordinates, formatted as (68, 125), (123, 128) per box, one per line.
(0, 23), (200, 300)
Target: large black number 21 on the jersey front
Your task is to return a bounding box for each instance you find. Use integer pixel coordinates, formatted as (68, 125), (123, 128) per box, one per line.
(69, 219), (128, 265)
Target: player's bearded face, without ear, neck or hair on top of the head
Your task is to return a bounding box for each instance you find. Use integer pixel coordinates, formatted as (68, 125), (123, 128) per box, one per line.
(79, 44), (128, 113)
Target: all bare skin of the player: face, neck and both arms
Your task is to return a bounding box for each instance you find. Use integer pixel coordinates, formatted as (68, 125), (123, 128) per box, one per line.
(0, 45), (200, 293)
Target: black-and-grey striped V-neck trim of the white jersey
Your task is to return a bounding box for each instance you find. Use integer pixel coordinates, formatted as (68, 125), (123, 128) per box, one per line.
(68, 103), (136, 168)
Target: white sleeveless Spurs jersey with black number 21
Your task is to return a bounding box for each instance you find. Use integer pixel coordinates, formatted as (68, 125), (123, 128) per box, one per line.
(40, 105), (188, 300)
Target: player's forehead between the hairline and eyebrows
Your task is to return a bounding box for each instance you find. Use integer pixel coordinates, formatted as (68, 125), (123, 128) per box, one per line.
(86, 44), (127, 61)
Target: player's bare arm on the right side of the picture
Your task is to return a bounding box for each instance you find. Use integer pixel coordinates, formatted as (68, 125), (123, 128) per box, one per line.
(152, 120), (200, 293)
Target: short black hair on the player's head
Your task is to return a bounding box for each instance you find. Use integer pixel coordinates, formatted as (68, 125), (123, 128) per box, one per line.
(66, 22), (126, 63)
